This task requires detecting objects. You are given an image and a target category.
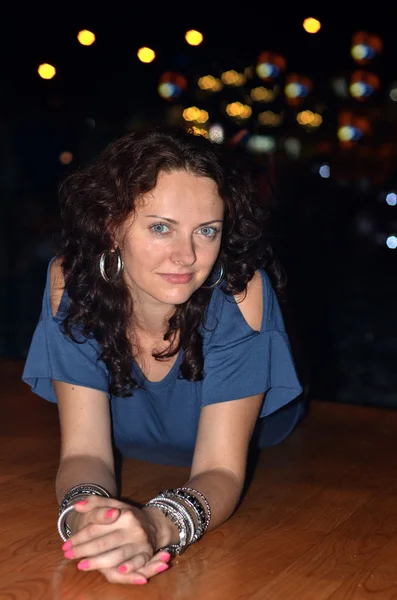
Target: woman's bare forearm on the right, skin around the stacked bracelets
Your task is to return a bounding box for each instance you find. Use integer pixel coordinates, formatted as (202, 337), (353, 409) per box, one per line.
(145, 469), (243, 547)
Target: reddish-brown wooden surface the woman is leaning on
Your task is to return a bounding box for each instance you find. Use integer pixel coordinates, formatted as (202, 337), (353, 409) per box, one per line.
(0, 361), (397, 600)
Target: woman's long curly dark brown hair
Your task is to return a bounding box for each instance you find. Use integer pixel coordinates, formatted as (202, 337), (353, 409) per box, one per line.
(56, 126), (285, 397)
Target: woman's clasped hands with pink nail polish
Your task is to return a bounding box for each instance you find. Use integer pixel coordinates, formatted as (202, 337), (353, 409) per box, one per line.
(62, 495), (171, 584)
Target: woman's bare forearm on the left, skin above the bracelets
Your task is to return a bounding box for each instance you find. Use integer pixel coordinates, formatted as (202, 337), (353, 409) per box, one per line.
(55, 455), (117, 530)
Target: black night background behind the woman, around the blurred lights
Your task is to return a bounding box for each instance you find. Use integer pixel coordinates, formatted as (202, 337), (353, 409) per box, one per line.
(0, 2), (397, 407)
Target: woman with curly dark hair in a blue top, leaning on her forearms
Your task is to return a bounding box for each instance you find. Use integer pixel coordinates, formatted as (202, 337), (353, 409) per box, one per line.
(23, 128), (303, 584)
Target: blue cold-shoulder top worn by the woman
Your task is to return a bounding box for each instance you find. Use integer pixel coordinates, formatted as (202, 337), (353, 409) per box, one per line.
(22, 259), (303, 466)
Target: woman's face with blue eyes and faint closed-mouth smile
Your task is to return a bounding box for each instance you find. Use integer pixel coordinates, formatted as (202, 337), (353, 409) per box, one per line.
(120, 171), (224, 305)
